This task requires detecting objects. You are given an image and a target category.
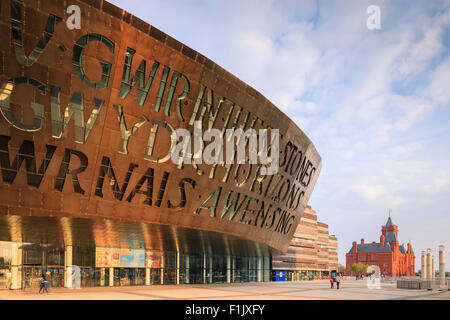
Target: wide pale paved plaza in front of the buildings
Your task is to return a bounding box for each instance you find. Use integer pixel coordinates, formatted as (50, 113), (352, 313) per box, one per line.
(0, 280), (450, 300)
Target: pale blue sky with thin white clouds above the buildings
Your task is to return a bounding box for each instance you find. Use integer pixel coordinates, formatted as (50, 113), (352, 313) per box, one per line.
(109, 0), (450, 271)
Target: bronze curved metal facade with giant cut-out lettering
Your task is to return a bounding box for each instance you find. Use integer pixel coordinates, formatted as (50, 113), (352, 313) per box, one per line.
(0, 0), (321, 260)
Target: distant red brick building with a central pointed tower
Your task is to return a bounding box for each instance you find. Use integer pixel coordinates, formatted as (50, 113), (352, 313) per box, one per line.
(346, 216), (415, 277)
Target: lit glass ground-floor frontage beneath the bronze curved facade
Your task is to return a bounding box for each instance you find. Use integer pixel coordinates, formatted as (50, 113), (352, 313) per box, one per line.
(0, 242), (271, 289)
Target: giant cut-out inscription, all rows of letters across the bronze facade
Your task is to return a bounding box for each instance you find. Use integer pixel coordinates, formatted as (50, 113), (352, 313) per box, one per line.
(0, 0), (317, 238)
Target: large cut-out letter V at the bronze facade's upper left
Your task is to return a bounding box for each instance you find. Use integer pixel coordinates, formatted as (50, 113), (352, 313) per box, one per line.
(10, 0), (62, 67)
